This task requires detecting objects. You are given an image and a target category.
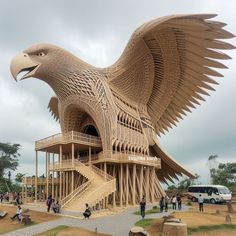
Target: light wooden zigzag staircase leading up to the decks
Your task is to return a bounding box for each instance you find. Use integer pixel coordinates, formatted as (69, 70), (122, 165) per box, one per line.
(61, 161), (116, 212)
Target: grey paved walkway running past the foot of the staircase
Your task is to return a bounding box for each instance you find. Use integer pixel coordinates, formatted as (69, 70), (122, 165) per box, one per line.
(3, 206), (188, 236)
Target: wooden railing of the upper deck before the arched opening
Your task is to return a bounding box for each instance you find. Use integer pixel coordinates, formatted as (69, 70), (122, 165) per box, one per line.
(35, 131), (102, 150)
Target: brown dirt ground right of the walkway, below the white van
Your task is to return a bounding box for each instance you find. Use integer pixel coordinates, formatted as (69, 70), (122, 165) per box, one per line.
(147, 203), (236, 236)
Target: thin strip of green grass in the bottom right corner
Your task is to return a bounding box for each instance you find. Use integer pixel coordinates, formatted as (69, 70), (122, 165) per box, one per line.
(188, 224), (236, 235)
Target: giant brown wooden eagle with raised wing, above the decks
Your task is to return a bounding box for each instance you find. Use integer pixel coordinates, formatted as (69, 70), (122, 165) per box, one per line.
(11, 14), (234, 187)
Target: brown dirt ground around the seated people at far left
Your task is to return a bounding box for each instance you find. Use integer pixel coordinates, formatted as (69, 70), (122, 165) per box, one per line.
(0, 204), (59, 234)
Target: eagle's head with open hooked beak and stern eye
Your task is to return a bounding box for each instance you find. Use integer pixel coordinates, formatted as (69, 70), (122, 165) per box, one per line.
(10, 44), (73, 81)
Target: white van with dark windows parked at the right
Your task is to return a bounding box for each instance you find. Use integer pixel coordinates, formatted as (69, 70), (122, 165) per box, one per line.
(188, 185), (232, 204)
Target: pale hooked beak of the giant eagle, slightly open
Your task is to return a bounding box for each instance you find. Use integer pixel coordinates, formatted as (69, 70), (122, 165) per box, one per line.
(10, 53), (39, 81)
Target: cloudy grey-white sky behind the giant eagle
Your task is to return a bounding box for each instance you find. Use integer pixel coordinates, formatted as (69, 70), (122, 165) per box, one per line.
(0, 0), (236, 183)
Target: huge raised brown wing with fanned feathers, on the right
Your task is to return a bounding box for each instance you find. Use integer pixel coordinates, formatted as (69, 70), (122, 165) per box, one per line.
(107, 14), (234, 135)
